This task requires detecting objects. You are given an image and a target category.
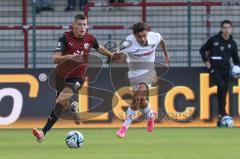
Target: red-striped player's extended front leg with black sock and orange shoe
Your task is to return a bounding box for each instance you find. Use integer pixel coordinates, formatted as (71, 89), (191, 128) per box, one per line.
(32, 87), (73, 142)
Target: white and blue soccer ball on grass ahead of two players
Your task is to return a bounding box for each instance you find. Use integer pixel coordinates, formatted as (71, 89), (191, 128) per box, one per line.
(65, 131), (84, 148)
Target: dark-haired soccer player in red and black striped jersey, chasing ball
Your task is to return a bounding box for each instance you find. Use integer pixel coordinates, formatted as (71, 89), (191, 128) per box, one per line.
(32, 14), (124, 142)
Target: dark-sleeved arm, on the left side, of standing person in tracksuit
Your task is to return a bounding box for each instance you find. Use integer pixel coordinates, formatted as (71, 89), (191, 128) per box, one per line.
(199, 38), (212, 69)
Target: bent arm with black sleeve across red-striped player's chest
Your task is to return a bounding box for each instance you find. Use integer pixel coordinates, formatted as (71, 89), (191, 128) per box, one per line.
(53, 34), (77, 64)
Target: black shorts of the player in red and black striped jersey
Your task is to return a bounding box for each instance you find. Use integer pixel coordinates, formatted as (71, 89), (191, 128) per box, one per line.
(55, 77), (84, 97)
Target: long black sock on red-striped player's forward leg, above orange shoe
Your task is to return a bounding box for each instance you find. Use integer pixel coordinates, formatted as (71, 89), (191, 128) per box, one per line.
(42, 104), (63, 135)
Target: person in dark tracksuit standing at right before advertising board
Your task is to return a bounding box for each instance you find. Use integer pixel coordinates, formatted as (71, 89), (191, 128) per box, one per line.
(200, 20), (240, 126)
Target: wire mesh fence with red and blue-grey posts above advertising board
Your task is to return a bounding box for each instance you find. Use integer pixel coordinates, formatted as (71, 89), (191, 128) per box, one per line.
(0, 0), (240, 68)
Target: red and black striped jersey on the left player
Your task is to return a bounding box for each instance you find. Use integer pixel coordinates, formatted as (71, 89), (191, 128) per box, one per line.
(55, 31), (99, 78)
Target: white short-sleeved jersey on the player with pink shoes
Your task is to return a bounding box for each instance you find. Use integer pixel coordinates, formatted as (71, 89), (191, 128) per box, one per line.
(120, 32), (162, 78)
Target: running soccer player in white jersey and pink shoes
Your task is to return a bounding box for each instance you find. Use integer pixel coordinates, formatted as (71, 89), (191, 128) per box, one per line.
(117, 22), (170, 138)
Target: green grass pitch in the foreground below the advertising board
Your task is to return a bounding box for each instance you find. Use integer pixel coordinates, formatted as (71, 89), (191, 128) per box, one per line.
(0, 128), (240, 159)
